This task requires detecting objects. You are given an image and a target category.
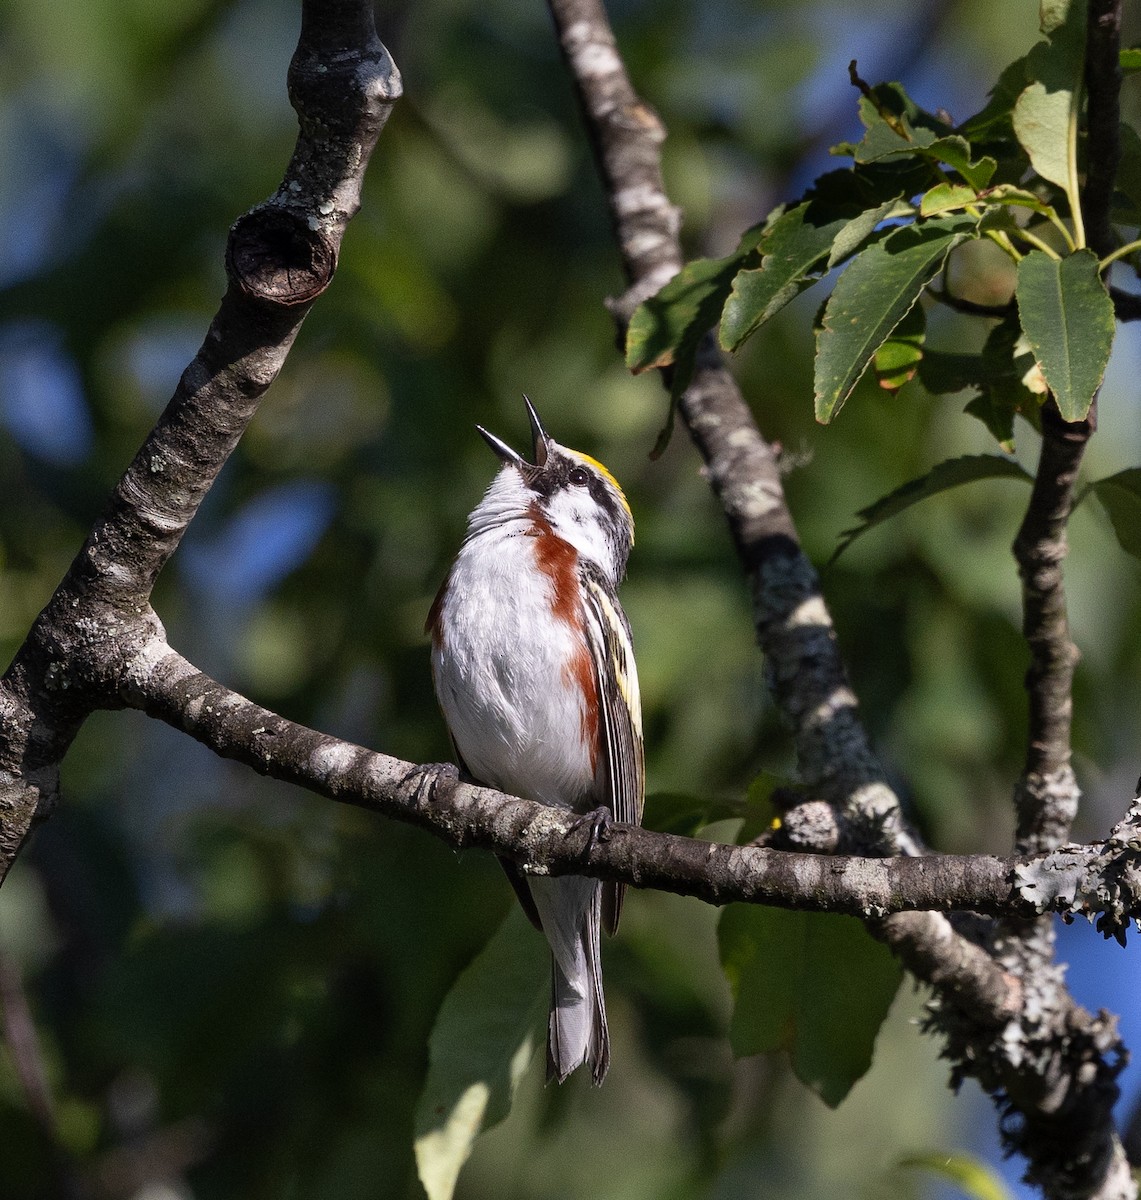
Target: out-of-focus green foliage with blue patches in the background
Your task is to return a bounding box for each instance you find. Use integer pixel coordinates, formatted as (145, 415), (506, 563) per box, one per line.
(0, 0), (1141, 1200)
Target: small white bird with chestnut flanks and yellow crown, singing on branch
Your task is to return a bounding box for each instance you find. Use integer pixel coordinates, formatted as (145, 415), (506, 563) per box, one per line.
(426, 396), (645, 1084)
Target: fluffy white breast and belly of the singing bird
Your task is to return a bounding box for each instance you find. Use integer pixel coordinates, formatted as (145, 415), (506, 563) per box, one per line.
(432, 521), (594, 808)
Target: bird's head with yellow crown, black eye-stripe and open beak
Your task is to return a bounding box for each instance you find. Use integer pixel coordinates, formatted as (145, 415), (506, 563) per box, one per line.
(476, 396), (633, 583)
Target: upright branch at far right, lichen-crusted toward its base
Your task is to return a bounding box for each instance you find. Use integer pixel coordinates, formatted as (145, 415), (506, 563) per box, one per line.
(949, 11), (1136, 1200)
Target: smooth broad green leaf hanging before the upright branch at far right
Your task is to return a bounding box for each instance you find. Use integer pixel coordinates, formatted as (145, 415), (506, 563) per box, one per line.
(1015, 250), (1115, 421)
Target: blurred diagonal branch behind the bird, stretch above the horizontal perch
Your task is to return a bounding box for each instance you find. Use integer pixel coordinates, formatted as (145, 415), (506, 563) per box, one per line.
(550, 0), (915, 851)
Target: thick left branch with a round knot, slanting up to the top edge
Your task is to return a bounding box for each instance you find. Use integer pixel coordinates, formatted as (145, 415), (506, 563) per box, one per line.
(0, 0), (401, 880)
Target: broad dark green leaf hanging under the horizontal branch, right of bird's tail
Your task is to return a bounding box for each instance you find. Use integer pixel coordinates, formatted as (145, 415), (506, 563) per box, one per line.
(717, 904), (902, 1108)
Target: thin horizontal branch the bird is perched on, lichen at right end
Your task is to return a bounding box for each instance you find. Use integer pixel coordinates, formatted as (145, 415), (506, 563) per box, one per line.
(122, 638), (1141, 932)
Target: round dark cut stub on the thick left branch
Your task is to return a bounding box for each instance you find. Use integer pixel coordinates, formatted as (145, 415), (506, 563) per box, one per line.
(226, 203), (337, 307)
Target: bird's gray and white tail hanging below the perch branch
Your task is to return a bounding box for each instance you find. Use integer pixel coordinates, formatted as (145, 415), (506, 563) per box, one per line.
(528, 876), (611, 1084)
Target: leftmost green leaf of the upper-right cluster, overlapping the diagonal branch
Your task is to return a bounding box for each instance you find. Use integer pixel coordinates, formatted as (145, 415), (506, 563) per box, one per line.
(626, 225), (780, 372)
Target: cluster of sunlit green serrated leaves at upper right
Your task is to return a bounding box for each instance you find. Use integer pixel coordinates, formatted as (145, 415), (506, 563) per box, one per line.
(626, 4), (1139, 436)
